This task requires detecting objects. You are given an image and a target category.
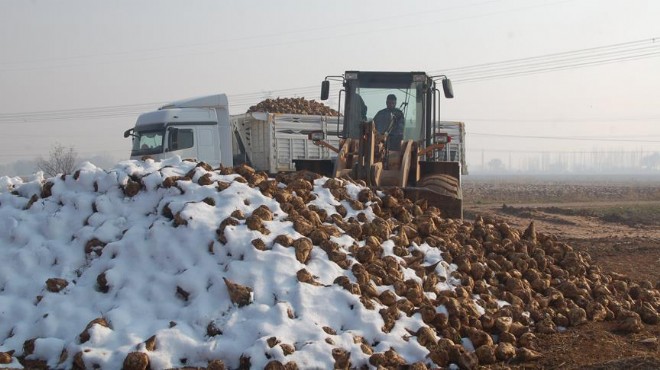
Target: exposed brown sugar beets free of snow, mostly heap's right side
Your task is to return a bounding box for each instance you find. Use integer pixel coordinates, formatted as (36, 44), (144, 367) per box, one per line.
(5, 163), (660, 369)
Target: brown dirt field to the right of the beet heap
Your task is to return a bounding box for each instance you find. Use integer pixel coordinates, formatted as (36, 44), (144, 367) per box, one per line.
(463, 176), (660, 369)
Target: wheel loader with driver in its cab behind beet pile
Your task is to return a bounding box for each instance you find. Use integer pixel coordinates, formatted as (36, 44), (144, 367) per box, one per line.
(294, 71), (463, 219)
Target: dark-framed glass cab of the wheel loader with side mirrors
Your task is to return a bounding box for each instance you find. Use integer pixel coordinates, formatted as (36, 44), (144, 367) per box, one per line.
(321, 71), (453, 152)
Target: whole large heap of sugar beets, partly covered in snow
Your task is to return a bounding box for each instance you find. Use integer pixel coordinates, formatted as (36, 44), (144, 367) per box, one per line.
(0, 158), (660, 369)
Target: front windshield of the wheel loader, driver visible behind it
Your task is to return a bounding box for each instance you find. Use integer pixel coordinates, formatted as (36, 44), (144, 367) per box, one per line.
(344, 76), (424, 140)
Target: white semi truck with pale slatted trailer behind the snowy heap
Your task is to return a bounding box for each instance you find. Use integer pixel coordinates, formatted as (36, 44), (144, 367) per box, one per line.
(124, 94), (342, 174)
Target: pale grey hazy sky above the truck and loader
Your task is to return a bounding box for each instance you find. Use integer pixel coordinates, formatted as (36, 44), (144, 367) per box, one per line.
(0, 0), (660, 172)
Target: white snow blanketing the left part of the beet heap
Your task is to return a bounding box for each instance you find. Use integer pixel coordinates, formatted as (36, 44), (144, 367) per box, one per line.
(0, 158), (469, 369)
